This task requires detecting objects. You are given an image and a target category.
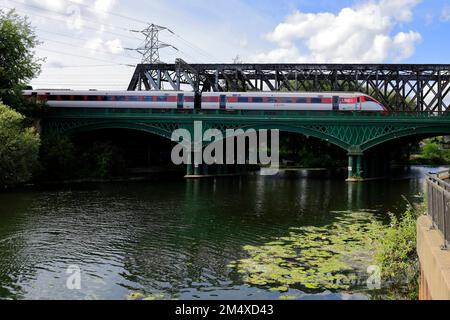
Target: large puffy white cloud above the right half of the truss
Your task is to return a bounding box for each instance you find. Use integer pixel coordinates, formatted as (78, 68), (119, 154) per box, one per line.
(254, 0), (422, 63)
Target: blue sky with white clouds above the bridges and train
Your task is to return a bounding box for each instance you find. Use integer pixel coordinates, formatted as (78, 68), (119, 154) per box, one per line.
(0, 0), (450, 90)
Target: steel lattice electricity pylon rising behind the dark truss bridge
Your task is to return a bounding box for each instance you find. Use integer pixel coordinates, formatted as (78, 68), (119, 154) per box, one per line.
(126, 23), (179, 64)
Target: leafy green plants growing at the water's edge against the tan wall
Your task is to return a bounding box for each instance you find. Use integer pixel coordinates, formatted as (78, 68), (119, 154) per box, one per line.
(376, 205), (419, 300)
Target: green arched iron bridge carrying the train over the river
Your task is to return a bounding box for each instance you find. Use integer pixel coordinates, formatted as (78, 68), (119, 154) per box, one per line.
(44, 108), (450, 180)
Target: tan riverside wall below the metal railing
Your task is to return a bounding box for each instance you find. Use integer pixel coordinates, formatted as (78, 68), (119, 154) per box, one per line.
(417, 216), (450, 300)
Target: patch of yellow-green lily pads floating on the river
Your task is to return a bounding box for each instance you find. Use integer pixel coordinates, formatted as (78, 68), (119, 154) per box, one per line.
(229, 212), (382, 298)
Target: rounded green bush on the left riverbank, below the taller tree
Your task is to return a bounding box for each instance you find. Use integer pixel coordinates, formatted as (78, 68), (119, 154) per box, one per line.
(0, 103), (40, 188)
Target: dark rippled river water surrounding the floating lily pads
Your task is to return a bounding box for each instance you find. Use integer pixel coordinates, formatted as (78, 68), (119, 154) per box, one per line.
(0, 167), (444, 299)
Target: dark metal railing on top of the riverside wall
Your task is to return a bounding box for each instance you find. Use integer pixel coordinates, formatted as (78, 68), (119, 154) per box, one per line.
(427, 170), (450, 249)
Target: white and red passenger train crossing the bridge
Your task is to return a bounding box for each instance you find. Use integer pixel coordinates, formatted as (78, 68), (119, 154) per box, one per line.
(23, 90), (388, 112)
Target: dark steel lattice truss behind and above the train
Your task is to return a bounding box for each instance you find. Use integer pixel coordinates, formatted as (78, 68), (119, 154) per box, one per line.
(128, 60), (450, 113)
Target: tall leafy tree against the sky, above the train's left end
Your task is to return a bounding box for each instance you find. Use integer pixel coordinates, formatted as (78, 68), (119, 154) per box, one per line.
(0, 9), (44, 112)
